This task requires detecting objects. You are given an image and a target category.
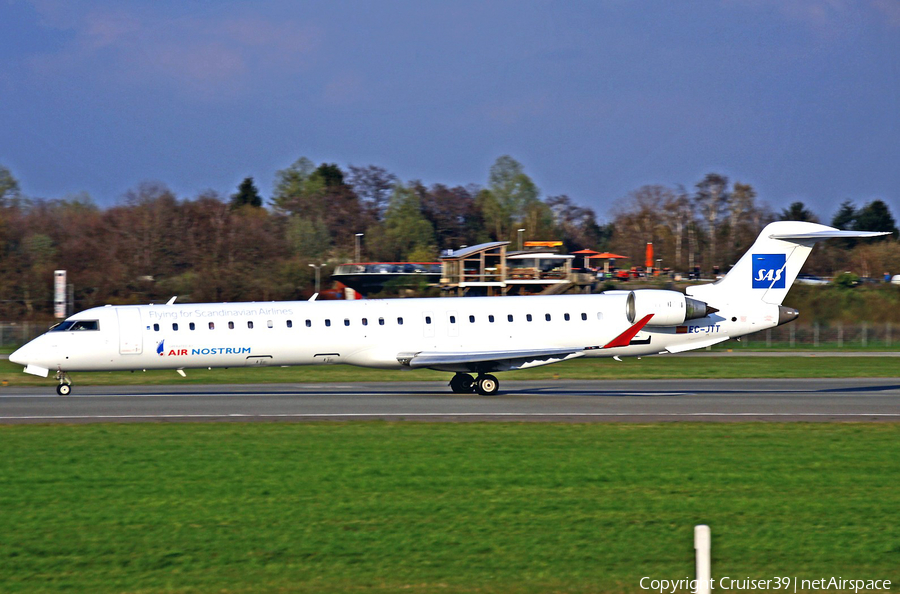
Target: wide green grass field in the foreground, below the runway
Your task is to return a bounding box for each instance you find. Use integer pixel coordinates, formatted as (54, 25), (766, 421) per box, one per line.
(0, 423), (900, 593)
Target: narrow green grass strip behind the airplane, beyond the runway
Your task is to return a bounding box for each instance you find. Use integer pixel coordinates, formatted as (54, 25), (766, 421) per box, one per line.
(0, 354), (900, 386)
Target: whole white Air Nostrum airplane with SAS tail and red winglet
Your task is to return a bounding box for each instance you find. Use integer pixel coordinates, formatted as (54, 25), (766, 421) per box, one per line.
(9, 221), (886, 396)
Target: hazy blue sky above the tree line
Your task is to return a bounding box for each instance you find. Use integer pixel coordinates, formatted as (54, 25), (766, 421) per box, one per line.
(0, 0), (900, 219)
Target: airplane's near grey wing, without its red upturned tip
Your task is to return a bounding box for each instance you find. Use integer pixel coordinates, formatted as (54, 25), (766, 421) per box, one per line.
(397, 348), (584, 369)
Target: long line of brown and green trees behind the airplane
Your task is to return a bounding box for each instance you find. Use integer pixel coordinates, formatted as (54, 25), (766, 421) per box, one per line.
(0, 156), (900, 319)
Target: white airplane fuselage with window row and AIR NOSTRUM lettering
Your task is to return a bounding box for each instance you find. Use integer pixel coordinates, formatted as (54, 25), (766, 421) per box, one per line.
(10, 294), (778, 373)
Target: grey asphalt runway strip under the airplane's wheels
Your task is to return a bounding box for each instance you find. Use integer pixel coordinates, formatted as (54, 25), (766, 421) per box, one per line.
(0, 378), (900, 424)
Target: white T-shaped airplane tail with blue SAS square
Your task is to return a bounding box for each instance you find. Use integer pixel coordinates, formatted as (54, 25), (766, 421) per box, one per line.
(687, 221), (887, 312)
